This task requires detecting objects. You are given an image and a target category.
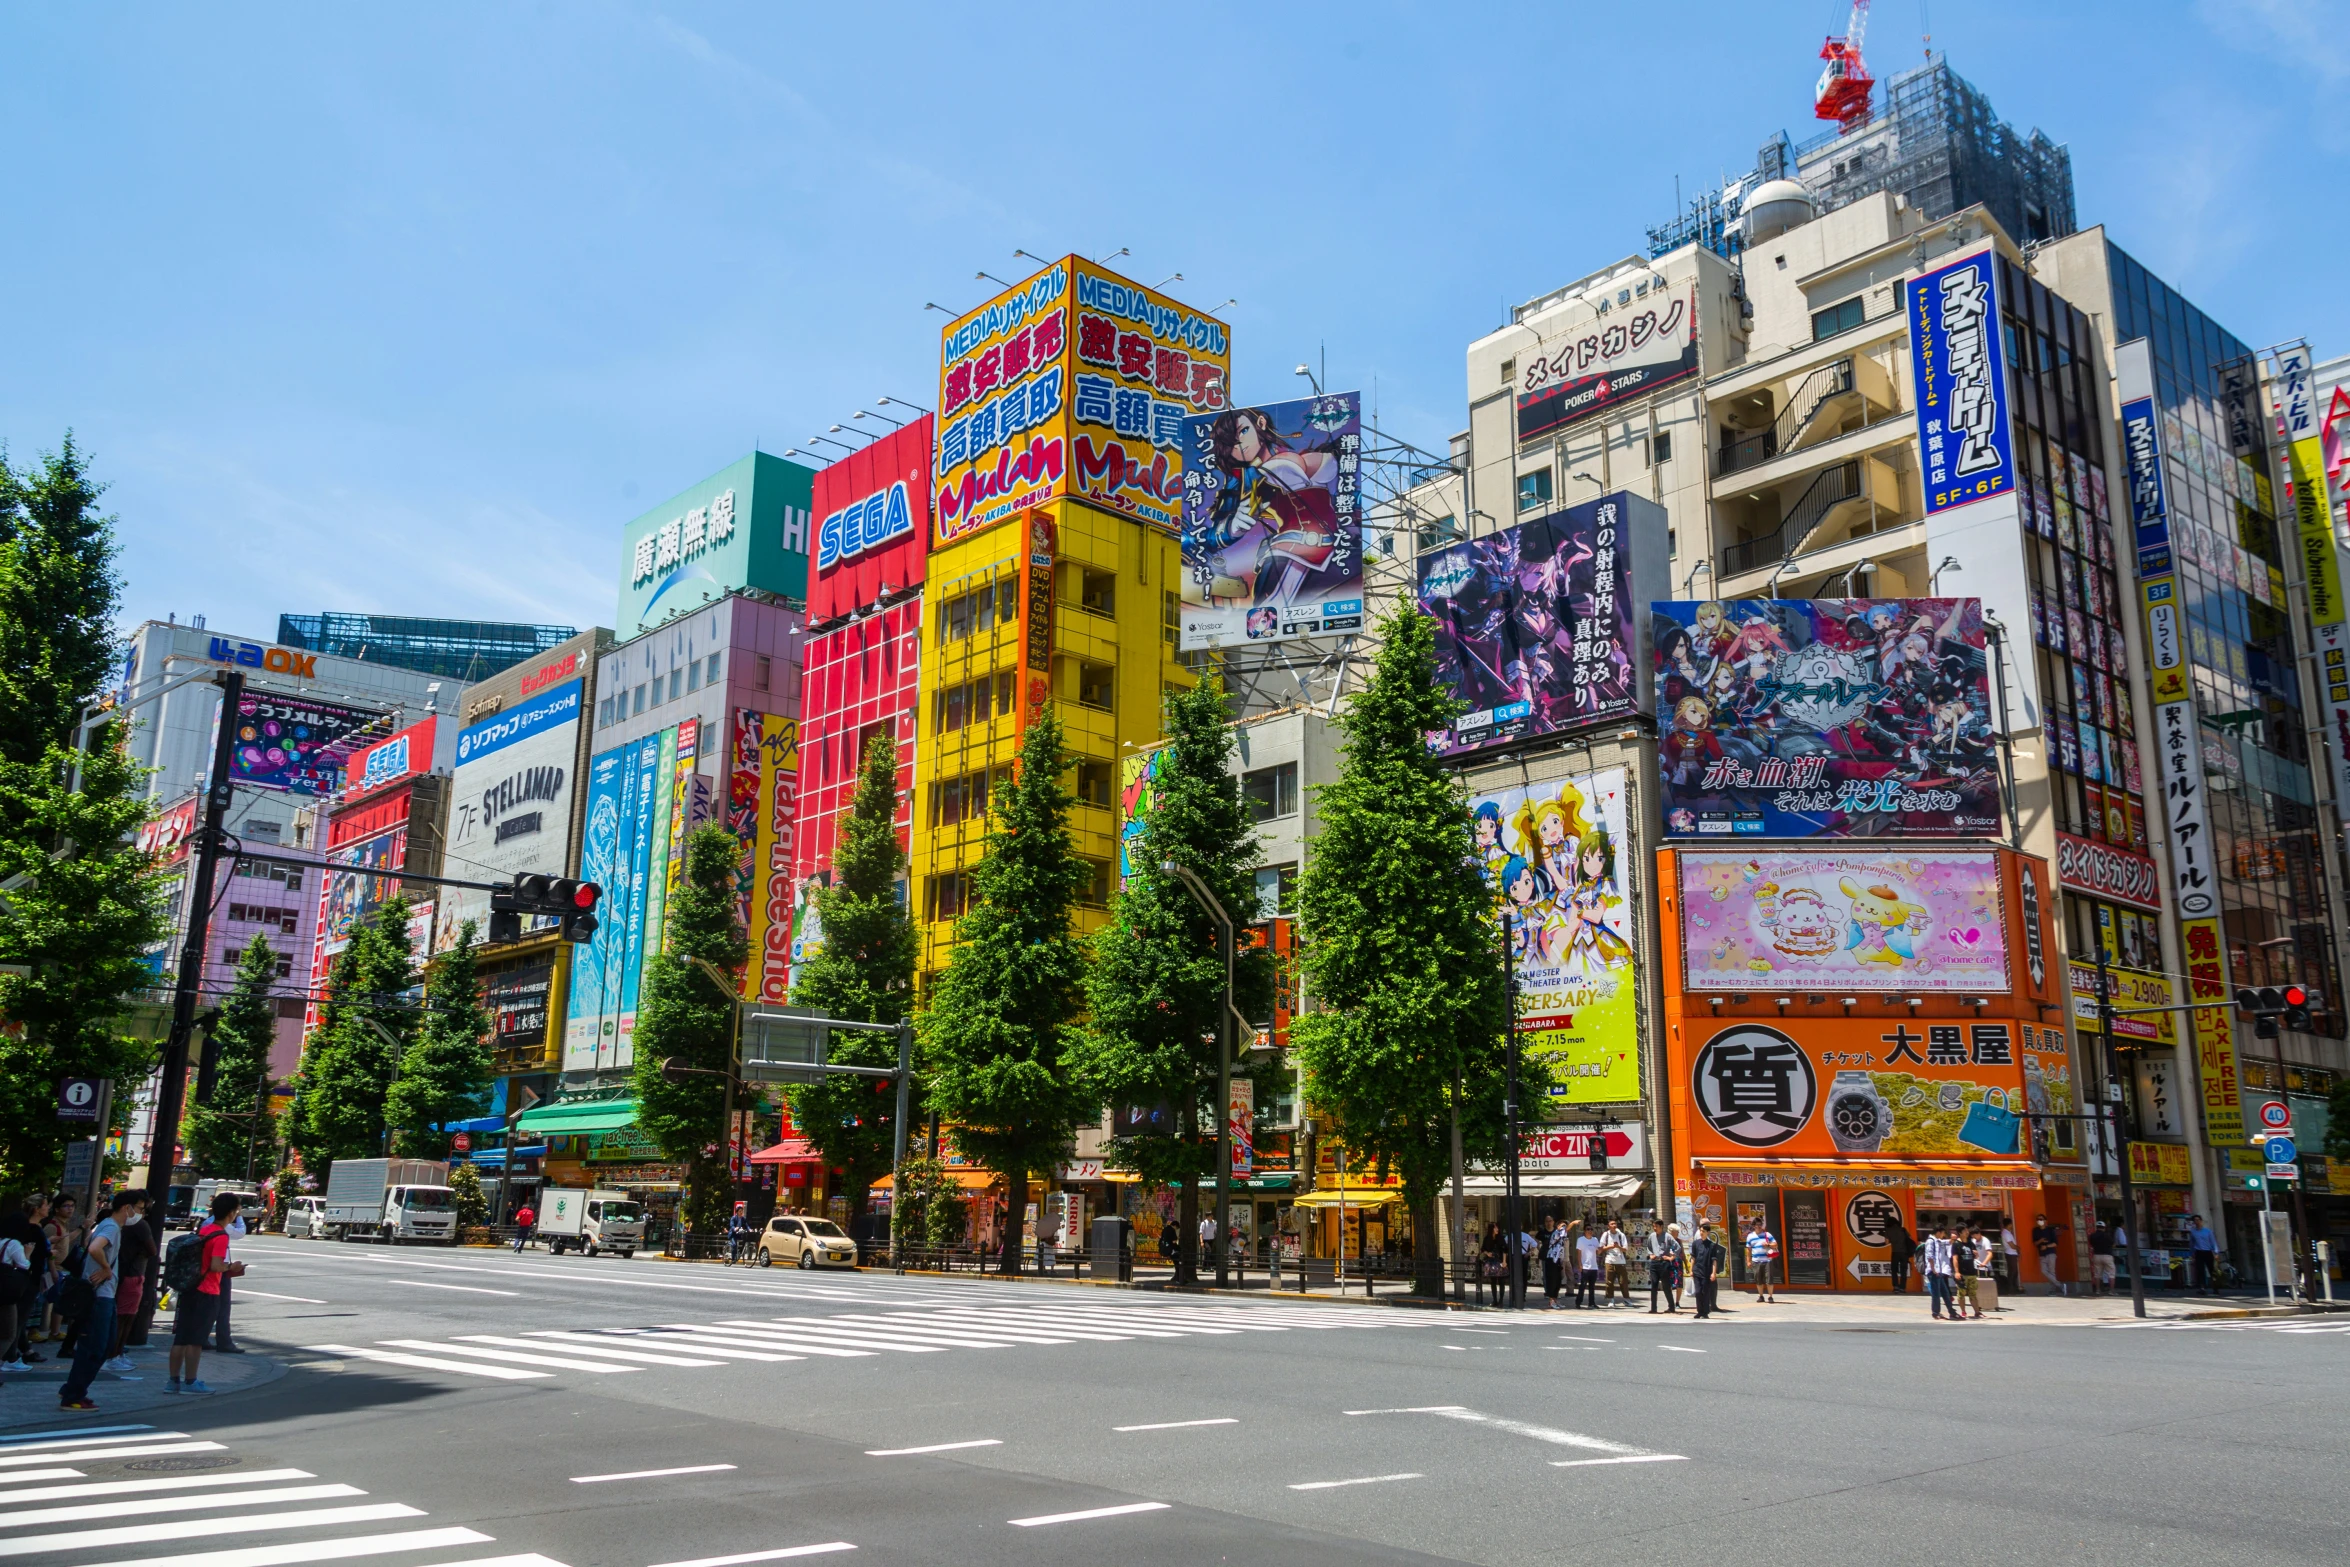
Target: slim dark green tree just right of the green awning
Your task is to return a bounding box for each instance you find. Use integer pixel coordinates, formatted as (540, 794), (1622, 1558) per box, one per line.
(635, 825), (750, 1233)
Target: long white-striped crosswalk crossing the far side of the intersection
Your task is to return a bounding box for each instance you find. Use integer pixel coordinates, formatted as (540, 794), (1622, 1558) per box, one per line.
(303, 1294), (1426, 1381)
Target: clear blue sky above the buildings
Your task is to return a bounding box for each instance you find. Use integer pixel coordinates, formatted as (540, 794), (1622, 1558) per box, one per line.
(0, 0), (2350, 637)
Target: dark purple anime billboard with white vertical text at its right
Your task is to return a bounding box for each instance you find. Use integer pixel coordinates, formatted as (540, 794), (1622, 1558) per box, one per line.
(1419, 491), (1666, 756)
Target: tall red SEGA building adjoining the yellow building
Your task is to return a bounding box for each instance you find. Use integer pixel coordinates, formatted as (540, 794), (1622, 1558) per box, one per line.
(792, 413), (931, 944)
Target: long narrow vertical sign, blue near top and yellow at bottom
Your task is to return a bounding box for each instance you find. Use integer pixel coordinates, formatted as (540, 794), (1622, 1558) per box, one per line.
(2115, 338), (2244, 1144)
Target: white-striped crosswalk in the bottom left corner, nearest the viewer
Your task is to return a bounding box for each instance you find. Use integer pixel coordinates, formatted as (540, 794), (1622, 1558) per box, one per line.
(0, 1426), (564, 1567)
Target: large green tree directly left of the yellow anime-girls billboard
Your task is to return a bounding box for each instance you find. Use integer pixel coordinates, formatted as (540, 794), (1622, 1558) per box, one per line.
(1290, 606), (1544, 1294)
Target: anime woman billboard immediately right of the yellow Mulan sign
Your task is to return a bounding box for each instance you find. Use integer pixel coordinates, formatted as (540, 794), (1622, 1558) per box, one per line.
(1180, 392), (1363, 651)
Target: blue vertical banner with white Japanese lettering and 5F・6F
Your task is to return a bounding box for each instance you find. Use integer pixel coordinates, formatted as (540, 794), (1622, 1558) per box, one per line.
(1908, 249), (2016, 517)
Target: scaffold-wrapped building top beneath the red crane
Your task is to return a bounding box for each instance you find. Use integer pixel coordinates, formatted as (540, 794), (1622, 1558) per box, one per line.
(1647, 59), (2077, 256)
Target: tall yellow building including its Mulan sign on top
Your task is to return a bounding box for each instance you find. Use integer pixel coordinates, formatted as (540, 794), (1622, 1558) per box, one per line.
(912, 256), (1229, 987)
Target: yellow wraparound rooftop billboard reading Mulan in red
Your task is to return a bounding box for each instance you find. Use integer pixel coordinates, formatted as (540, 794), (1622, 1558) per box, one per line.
(933, 256), (1231, 545)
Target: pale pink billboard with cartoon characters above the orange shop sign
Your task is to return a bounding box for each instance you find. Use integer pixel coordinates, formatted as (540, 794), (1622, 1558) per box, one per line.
(1678, 850), (2014, 996)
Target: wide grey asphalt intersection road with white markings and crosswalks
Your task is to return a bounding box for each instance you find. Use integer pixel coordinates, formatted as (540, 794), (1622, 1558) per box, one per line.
(0, 1238), (2350, 1567)
